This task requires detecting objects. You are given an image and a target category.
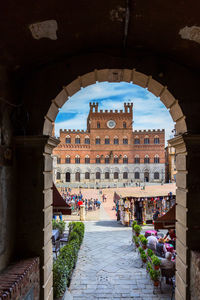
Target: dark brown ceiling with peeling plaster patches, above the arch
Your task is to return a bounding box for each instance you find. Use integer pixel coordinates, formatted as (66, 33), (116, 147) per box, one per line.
(0, 0), (200, 68)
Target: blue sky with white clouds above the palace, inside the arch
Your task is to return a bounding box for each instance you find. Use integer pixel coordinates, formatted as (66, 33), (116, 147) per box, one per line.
(55, 82), (174, 144)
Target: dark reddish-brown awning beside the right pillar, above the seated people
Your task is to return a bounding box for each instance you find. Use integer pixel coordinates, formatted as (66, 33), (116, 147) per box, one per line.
(154, 205), (176, 229)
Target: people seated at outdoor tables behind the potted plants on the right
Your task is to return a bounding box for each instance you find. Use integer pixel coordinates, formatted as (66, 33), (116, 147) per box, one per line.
(147, 229), (176, 270)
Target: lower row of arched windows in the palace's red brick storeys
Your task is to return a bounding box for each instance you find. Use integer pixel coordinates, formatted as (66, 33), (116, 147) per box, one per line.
(57, 155), (160, 164)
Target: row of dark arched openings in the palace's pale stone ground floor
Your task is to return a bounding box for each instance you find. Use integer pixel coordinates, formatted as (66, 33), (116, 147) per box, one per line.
(56, 172), (160, 182)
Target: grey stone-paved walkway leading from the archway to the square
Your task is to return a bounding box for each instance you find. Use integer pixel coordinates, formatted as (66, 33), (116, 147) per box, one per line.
(69, 208), (171, 300)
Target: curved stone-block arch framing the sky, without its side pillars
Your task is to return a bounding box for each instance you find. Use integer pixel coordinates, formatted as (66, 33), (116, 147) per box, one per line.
(43, 69), (187, 136)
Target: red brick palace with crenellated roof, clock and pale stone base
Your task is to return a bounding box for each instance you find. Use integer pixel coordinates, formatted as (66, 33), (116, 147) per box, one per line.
(53, 103), (165, 187)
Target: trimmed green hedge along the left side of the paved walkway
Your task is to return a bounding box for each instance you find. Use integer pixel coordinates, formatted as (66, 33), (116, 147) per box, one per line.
(53, 222), (85, 298)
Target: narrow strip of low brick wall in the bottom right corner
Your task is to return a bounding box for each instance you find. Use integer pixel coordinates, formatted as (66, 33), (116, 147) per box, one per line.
(190, 251), (200, 300)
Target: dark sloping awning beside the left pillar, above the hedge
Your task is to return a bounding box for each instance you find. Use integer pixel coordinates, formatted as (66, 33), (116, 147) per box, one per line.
(53, 183), (71, 215)
